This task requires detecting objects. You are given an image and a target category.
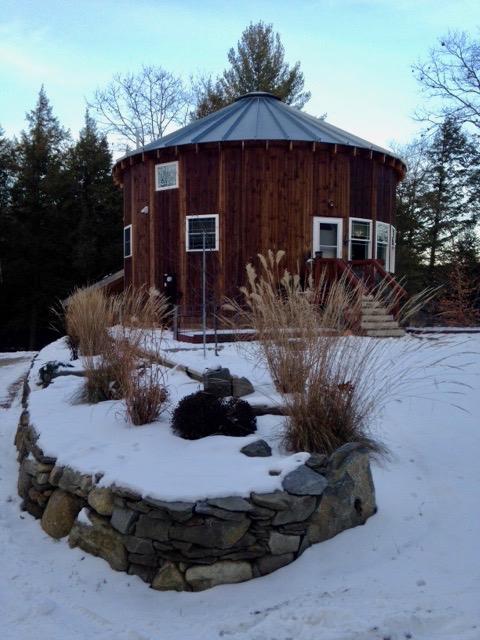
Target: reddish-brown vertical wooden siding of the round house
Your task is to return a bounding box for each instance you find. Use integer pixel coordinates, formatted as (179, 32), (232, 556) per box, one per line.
(123, 143), (398, 310)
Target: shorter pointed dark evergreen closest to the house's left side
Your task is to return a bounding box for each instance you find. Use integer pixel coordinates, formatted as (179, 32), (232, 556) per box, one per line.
(67, 111), (123, 284)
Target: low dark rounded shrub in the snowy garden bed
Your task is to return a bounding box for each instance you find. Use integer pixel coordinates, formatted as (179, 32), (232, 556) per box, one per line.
(172, 391), (257, 440)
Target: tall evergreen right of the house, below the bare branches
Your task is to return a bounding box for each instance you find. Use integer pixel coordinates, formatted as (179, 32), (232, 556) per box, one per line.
(420, 118), (478, 278)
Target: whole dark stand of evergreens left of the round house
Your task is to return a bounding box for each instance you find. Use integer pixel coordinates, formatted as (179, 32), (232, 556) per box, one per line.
(0, 87), (122, 349)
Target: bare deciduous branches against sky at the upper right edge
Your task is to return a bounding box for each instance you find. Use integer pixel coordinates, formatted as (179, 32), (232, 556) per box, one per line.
(412, 31), (480, 128)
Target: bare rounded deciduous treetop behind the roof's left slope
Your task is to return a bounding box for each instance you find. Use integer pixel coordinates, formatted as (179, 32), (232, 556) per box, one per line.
(88, 65), (189, 147)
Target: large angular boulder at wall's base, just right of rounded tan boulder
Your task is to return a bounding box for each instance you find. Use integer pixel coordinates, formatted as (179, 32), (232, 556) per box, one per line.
(68, 518), (128, 571)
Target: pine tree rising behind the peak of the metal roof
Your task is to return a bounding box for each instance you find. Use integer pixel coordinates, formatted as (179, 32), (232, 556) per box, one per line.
(193, 21), (310, 119)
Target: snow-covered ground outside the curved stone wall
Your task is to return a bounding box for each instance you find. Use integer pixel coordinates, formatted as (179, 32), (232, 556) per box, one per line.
(0, 335), (480, 640)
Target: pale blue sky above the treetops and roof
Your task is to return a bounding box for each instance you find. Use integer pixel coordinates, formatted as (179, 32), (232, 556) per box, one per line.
(0, 0), (480, 150)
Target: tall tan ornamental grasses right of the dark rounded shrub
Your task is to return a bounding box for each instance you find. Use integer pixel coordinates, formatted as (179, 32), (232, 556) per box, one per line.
(227, 252), (382, 454)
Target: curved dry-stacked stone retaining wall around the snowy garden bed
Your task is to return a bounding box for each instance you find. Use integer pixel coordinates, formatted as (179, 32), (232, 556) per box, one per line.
(15, 409), (376, 591)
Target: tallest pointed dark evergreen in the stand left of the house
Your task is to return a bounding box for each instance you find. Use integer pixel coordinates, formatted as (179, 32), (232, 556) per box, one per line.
(5, 87), (74, 348)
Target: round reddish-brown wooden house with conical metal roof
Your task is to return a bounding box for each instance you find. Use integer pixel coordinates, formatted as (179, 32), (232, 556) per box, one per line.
(114, 92), (405, 315)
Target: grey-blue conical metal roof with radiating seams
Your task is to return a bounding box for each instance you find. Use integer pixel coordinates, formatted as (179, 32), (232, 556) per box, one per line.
(129, 91), (393, 162)
